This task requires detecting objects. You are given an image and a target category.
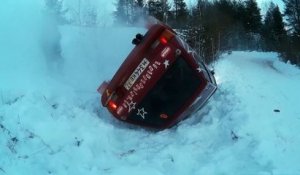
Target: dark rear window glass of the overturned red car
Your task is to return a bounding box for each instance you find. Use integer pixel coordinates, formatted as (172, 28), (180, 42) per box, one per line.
(128, 57), (201, 126)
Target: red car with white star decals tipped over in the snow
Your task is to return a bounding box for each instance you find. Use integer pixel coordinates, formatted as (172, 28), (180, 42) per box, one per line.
(98, 24), (217, 129)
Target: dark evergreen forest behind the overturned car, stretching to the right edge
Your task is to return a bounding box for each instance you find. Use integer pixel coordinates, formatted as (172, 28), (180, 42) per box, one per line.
(114, 0), (300, 65)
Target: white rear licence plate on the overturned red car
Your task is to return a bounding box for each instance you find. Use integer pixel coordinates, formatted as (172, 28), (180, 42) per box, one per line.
(124, 58), (150, 90)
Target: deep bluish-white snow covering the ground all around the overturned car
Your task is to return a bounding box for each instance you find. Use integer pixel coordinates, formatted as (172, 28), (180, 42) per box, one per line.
(0, 1), (300, 175)
